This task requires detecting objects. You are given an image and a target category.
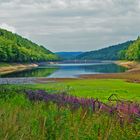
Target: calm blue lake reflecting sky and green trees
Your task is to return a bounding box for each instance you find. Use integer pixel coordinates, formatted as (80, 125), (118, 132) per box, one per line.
(1, 62), (127, 78)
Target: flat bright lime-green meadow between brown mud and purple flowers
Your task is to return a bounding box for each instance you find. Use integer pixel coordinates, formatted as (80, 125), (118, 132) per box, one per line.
(4, 79), (140, 102)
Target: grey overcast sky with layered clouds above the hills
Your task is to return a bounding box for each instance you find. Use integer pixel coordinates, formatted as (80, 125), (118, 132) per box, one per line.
(0, 0), (140, 51)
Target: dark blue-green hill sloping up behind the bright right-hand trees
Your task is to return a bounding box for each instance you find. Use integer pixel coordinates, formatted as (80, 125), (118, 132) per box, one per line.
(77, 41), (133, 60)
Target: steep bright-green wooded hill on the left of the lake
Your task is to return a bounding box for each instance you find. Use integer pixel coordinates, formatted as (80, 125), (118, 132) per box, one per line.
(0, 29), (58, 62)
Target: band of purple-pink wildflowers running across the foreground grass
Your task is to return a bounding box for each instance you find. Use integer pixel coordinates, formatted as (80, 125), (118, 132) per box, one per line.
(25, 90), (140, 118)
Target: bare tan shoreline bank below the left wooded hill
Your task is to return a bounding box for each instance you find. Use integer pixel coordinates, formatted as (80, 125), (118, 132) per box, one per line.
(0, 64), (38, 75)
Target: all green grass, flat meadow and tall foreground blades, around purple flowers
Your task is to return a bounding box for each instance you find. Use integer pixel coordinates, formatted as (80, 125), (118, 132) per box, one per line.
(0, 80), (140, 140)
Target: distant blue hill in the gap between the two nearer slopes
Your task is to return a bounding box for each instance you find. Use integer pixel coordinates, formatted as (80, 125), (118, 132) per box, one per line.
(56, 52), (83, 60)
